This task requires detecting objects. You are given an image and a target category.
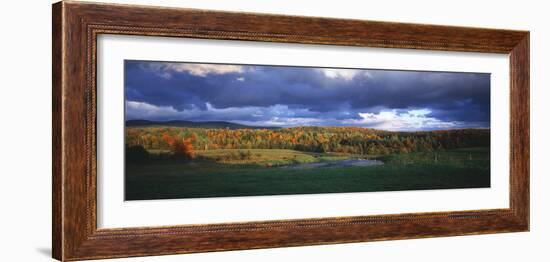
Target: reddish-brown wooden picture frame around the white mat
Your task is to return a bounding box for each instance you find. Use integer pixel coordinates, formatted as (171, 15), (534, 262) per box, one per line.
(52, 1), (529, 261)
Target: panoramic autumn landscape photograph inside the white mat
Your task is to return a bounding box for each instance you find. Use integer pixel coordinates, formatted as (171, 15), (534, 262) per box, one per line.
(124, 60), (491, 201)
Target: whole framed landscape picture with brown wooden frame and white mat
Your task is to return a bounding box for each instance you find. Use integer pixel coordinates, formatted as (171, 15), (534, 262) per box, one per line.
(52, 1), (529, 261)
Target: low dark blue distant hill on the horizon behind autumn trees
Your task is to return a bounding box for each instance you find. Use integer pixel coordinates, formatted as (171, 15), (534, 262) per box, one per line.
(126, 120), (280, 129)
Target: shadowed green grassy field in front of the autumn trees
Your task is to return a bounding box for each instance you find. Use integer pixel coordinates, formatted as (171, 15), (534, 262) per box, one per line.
(125, 147), (490, 200)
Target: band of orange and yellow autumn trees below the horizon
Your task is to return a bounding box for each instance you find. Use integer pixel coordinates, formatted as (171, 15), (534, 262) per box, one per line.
(126, 127), (490, 158)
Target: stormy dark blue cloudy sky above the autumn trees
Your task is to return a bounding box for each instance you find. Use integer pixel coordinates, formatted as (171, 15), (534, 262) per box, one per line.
(124, 60), (490, 131)
